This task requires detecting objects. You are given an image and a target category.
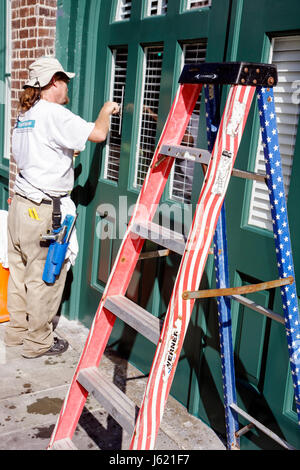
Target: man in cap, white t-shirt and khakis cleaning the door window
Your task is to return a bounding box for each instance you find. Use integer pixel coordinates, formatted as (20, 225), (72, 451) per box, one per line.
(5, 57), (119, 358)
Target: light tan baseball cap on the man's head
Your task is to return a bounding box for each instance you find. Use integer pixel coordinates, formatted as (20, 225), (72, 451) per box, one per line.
(23, 57), (75, 88)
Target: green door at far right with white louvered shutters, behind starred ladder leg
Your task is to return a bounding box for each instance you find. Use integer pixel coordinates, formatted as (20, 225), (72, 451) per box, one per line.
(218, 0), (300, 449)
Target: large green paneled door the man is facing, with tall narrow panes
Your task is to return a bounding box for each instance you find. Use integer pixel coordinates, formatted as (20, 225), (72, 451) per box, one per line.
(57, 0), (230, 436)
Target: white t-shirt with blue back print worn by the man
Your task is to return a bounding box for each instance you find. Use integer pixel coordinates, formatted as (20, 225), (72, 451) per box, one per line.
(12, 100), (95, 199)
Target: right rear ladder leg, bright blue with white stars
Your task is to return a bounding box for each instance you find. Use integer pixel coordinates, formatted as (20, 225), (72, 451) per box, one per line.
(257, 87), (300, 424)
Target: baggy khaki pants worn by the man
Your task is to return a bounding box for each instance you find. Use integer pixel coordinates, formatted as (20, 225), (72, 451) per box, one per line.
(5, 195), (67, 357)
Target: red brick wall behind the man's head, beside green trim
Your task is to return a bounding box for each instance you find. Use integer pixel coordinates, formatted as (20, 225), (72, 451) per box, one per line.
(9, 0), (57, 197)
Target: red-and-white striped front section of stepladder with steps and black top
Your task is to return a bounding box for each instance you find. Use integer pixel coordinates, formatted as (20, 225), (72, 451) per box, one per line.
(48, 60), (288, 450)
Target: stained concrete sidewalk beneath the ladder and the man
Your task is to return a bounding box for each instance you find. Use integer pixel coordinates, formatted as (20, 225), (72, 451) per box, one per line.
(0, 317), (225, 451)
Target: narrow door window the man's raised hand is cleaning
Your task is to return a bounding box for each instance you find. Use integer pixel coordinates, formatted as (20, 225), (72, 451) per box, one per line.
(104, 47), (128, 182)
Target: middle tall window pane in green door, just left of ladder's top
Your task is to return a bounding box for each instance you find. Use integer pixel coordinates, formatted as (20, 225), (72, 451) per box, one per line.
(134, 46), (163, 187)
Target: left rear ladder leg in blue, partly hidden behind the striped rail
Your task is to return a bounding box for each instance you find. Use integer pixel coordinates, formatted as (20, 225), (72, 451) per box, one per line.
(205, 85), (239, 449)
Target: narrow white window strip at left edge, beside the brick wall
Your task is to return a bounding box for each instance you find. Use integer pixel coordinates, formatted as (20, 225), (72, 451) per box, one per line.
(0, 0), (11, 159)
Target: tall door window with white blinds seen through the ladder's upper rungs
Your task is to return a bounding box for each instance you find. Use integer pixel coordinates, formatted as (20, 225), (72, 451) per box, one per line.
(170, 40), (206, 203)
